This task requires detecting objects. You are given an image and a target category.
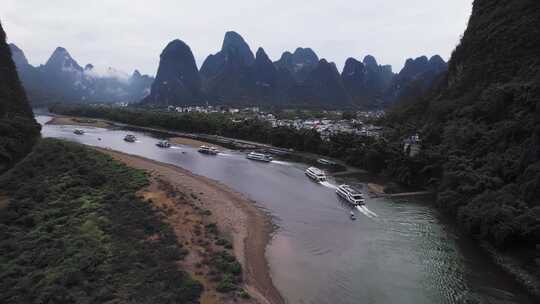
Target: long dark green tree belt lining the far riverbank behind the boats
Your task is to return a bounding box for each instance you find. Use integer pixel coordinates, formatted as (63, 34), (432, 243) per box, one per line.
(50, 104), (427, 186)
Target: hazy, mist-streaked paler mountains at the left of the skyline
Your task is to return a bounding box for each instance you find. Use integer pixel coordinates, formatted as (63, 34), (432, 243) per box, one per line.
(9, 44), (154, 105)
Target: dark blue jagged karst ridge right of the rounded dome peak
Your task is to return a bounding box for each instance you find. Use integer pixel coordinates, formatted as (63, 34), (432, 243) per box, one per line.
(143, 31), (446, 109)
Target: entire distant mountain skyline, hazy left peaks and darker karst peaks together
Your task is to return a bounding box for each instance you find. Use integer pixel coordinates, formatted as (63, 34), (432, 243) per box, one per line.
(10, 31), (447, 109)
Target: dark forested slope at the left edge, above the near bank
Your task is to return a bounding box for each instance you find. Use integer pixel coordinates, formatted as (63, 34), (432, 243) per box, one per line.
(0, 24), (40, 174)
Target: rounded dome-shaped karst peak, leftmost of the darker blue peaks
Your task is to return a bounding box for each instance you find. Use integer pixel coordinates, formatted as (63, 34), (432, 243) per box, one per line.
(144, 40), (204, 106)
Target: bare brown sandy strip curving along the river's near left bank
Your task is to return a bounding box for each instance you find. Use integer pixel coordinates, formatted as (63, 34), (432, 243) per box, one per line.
(96, 148), (284, 303)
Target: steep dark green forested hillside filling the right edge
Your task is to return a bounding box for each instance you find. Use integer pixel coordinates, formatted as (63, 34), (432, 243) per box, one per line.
(388, 0), (540, 247)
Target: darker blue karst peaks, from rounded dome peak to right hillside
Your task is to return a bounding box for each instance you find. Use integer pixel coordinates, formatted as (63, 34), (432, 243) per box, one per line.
(143, 32), (447, 109)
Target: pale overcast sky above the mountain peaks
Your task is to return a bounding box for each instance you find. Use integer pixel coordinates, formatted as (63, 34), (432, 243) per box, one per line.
(0, 0), (472, 75)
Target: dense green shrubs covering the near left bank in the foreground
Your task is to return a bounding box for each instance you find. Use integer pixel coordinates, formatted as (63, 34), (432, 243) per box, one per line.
(0, 139), (202, 303)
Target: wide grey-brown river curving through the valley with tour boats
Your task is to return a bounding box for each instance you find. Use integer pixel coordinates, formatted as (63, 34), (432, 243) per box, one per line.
(37, 116), (535, 304)
